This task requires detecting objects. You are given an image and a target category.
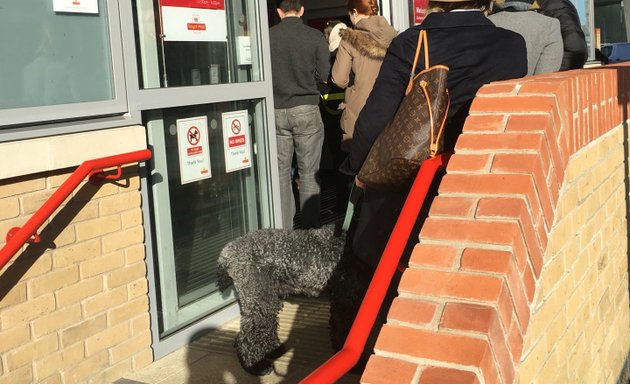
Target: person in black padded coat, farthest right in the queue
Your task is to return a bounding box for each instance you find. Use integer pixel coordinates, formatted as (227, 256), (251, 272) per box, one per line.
(537, 0), (588, 71)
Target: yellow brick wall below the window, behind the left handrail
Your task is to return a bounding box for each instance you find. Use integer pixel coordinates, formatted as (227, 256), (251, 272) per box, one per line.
(0, 166), (153, 384)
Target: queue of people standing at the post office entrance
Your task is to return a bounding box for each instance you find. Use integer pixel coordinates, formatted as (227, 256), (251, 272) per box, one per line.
(271, 0), (586, 368)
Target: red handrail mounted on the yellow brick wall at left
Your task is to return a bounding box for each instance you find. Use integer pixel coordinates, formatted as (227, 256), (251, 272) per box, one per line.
(0, 149), (151, 270)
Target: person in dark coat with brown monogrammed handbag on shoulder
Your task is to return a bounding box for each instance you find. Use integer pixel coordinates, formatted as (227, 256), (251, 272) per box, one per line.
(331, 0), (527, 365)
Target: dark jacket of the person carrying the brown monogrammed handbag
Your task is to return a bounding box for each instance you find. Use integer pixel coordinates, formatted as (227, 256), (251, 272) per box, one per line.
(340, 11), (527, 176)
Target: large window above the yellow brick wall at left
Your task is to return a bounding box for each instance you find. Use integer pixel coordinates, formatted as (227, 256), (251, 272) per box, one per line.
(0, 0), (126, 125)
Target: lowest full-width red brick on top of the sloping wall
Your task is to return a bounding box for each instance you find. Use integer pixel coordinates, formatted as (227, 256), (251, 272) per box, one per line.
(375, 324), (489, 366)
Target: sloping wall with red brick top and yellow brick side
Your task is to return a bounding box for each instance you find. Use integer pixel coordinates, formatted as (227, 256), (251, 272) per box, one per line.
(361, 66), (630, 384)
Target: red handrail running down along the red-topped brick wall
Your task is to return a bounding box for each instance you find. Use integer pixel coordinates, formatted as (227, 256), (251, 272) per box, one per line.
(300, 152), (452, 384)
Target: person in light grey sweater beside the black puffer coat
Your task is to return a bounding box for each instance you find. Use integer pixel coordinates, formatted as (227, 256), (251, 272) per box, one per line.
(488, 0), (563, 76)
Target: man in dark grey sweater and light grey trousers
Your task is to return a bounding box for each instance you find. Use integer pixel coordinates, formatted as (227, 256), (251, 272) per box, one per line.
(269, 0), (330, 229)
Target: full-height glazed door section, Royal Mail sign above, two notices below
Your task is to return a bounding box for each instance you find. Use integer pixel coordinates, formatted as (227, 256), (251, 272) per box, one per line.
(132, 0), (279, 342)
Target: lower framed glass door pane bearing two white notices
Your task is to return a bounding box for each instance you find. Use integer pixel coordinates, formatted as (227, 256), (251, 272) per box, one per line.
(147, 100), (270, 336)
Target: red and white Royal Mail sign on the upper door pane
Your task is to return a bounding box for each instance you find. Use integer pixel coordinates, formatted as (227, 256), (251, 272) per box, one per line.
(160, 0), (227, 41)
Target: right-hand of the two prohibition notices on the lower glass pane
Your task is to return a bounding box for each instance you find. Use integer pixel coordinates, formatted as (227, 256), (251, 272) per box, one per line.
(221, 111), (252, 173)
